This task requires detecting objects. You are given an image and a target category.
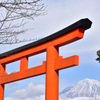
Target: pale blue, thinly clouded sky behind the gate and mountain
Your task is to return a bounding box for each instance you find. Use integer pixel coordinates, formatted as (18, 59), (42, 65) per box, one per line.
(0, 0), (100, 100)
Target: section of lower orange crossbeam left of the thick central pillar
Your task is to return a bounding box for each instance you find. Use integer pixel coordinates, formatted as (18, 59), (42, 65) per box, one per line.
(0, 62), (46, 84)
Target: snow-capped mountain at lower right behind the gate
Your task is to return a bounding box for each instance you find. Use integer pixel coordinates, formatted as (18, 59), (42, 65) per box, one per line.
(60, 79), (100, 98)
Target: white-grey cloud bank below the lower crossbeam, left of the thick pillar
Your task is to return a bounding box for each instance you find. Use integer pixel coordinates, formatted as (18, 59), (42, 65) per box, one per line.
(4, 83), (45, 100)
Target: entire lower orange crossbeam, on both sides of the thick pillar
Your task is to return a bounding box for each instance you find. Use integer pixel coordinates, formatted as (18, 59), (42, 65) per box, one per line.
(0, 55), (79, 84)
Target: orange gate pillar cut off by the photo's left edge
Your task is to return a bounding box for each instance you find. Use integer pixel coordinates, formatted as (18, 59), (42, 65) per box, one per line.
(0, 64), (5, 100)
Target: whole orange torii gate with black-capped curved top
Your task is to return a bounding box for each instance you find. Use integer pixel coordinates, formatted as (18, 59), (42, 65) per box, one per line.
(0, 18), (92, 100)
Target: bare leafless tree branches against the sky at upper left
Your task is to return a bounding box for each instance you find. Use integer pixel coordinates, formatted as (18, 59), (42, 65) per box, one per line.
(0, 0), (46, 44)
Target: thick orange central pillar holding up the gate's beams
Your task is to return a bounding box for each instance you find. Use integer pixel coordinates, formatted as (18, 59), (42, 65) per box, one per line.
(46, 46), (59, 100)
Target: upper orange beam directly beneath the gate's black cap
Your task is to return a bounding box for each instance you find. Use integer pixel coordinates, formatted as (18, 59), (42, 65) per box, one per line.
(0, 28), (84, 64)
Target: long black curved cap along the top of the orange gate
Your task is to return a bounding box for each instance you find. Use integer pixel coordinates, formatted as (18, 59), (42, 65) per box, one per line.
(0, 18), (92, 58)
